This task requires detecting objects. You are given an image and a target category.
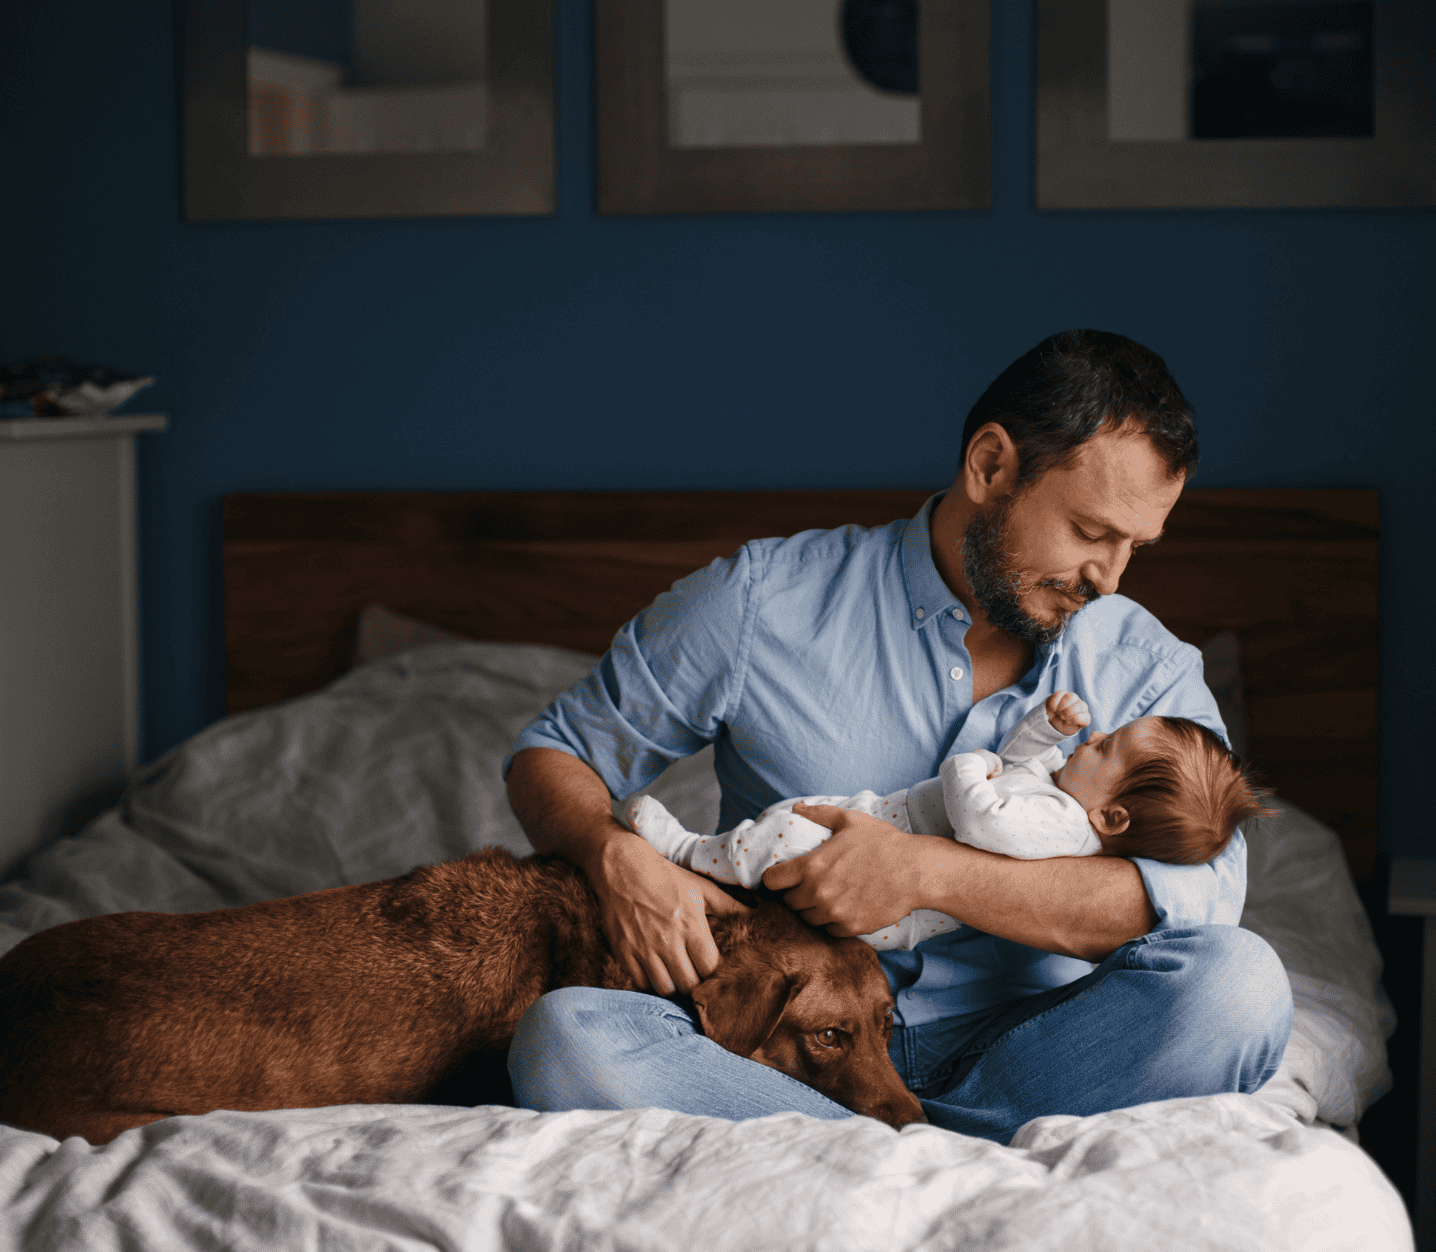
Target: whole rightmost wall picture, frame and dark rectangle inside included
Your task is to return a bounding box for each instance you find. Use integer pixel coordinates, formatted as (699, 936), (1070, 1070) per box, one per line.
(1037, 0), (1436, 208)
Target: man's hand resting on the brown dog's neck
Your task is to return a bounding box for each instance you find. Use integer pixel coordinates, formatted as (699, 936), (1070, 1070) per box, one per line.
(589, 836), (747, 995)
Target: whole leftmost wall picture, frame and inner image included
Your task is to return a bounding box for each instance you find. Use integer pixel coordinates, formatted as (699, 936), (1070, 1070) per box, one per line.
(182, 0), (554, 221)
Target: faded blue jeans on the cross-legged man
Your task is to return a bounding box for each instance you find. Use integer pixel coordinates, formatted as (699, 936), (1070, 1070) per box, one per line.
(508, 926), (1291, 1143)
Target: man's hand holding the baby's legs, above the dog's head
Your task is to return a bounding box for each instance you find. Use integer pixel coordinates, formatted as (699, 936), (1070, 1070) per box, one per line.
(763, 801), (925, 936)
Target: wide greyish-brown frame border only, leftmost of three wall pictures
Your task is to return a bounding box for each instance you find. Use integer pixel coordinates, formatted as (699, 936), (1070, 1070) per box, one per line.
(181, 0), (554, 221)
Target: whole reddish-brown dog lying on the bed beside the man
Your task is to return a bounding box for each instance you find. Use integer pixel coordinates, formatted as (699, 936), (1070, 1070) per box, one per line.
(0, 849), (922, 1143)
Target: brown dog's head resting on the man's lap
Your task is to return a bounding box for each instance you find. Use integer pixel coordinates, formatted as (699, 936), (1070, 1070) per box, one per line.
(692, 903), (922, 1126)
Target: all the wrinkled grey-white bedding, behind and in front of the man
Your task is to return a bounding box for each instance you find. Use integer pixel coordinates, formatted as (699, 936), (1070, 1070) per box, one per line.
(0, 643), (1410, 1252)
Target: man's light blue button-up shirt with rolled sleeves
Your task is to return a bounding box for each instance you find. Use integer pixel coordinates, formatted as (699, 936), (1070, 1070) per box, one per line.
(505, 495), (1246, 1025)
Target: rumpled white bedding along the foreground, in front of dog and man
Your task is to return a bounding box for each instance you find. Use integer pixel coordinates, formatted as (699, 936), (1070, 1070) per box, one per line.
(0, 1096), (1410, 1252)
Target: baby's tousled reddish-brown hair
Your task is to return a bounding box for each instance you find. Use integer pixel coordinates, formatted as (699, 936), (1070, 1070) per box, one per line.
(1101, 716), (1274, 866)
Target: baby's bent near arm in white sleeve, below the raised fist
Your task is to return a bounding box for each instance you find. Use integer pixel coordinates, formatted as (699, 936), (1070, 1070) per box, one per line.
(938, 752), (1100, 860)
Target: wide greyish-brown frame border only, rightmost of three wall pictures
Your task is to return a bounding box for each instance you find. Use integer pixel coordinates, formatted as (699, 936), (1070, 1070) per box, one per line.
(1037, 0), (1436, 210)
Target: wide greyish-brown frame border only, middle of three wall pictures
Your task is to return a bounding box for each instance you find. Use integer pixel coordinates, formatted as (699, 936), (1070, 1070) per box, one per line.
(596, 0), (991, 214)
